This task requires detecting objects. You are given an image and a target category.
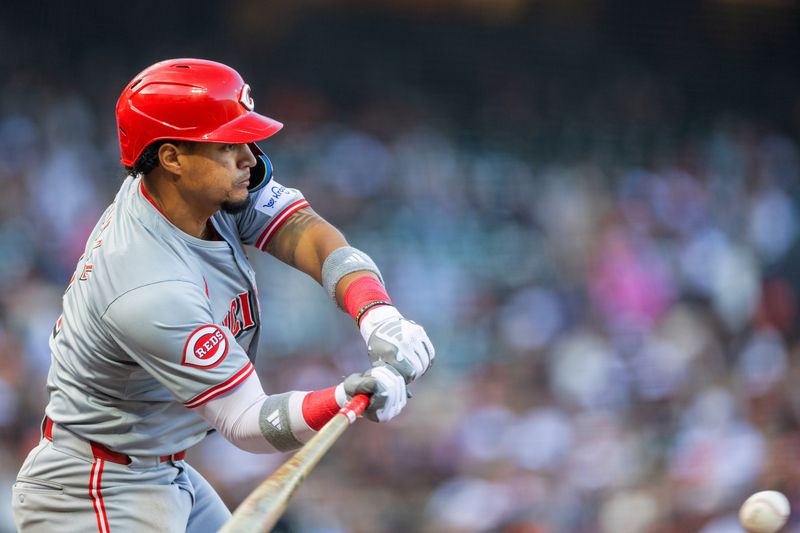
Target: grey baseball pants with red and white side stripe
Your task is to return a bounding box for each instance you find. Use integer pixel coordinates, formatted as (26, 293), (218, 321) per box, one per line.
(11, 425), (230, 533)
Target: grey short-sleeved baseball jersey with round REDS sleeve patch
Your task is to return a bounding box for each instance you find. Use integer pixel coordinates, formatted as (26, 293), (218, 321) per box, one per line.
(46, 177), (308, 456)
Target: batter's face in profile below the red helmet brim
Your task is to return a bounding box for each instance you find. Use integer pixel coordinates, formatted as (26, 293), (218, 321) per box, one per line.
(181, 143), (256, 211)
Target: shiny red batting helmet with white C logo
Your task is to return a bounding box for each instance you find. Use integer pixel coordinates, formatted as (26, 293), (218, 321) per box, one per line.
(117, 59), (283, 166)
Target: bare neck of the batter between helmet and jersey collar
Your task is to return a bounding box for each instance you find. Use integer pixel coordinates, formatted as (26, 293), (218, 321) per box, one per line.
(142, 174), (214, 239)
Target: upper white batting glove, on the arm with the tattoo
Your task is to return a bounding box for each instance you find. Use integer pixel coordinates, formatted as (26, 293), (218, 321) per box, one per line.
(360, 305), (436, 383)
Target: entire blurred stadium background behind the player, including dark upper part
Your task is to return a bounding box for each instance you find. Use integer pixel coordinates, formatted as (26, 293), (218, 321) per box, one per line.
(0, 0), (800, 533)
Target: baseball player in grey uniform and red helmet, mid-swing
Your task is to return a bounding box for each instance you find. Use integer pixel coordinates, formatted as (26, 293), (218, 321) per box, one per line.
(12, 59), (434, 533)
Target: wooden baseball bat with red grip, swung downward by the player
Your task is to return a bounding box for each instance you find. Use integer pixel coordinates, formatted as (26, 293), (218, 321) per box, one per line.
(219, 394), (369, 533)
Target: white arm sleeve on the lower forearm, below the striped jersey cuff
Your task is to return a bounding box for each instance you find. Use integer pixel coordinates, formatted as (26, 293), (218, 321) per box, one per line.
(195, 373), (314, 453)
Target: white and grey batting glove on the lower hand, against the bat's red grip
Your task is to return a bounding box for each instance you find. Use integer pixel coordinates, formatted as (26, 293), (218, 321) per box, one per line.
(336, 365), (407, 422)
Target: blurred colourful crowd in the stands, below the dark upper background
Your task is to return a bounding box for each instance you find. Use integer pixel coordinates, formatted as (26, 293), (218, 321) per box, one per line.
(0, 47), (800, 533)
